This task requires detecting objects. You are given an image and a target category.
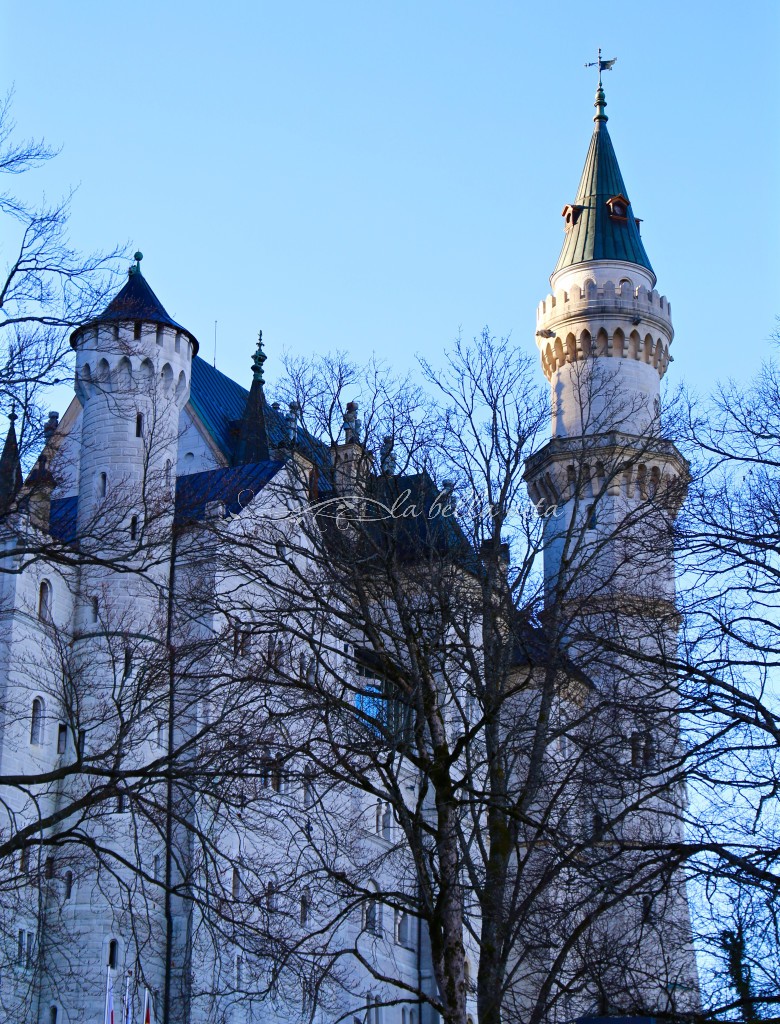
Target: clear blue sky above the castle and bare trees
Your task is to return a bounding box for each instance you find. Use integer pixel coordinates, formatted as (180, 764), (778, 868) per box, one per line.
(1, 0), (780, 405)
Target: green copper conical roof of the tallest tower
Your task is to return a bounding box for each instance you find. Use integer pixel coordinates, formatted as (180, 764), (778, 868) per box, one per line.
(554, 85), (653, 273)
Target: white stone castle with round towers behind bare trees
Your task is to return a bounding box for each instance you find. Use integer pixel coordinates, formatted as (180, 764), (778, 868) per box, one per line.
(0, 85), (698, 1024)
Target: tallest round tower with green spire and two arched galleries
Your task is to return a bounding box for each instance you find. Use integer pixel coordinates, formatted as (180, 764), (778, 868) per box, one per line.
(525, 79), (698, 1017)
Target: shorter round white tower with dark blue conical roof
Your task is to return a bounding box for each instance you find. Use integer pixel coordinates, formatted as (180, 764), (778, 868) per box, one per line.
(49, 253), (198, 1019)
